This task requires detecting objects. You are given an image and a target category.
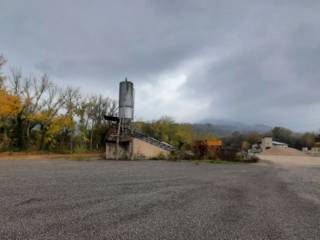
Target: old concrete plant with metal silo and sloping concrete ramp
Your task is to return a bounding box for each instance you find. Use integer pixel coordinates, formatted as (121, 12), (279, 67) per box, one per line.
(105, 79), (174, 160)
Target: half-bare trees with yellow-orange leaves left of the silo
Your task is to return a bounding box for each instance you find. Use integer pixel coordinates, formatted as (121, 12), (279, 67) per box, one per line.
(0, 56), (116, 152)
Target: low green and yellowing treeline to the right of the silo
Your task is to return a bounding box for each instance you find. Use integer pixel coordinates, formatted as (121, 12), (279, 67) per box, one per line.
(135, 121), (317, 150)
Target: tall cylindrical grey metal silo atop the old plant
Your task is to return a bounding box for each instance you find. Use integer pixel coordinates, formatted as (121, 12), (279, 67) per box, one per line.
(119, 79), (134, 121)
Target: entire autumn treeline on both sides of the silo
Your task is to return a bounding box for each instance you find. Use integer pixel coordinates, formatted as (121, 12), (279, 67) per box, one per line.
(0, 56), (315, 152)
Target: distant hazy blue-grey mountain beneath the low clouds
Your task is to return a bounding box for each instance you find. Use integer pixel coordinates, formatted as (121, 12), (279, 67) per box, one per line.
(192, 119), (273, 137)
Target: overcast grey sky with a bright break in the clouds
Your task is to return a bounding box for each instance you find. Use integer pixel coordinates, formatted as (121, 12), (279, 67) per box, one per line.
(0, 0), (320, 131)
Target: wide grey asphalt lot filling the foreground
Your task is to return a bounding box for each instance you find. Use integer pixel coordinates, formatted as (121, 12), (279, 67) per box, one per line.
(0, 160), (320, 240)
